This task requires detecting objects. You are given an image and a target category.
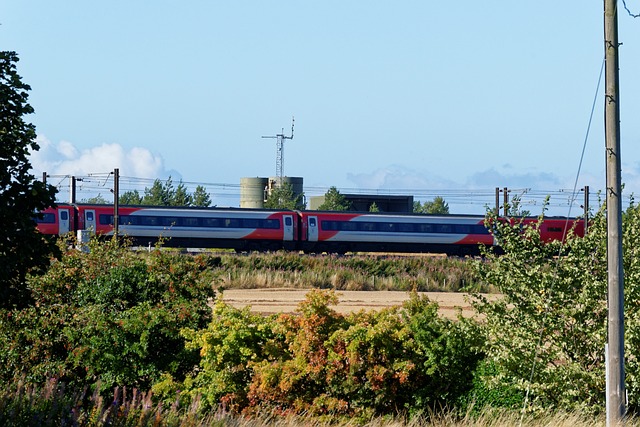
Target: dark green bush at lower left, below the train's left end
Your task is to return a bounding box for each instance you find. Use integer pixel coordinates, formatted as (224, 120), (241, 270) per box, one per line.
(0, 237), (214, 390)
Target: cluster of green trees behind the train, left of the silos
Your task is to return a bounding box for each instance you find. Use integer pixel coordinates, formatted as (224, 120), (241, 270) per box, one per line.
(118, 177), (211, 207)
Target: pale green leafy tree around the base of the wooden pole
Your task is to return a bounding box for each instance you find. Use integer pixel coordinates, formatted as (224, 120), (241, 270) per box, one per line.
(476, 208), (616, 411)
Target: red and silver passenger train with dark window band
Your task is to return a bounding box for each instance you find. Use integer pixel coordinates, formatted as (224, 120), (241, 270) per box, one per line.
(37, 204), (584, 255)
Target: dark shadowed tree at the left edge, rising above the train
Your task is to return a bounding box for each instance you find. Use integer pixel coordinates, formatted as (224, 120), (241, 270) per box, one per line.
(0, 51), (56, 308)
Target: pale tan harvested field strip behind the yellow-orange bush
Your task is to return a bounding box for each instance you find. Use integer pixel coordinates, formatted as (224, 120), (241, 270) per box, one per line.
(223, 288), (488, 318)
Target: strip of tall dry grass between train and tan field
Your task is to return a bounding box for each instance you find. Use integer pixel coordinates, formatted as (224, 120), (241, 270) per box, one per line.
(215, 252), (491, 292)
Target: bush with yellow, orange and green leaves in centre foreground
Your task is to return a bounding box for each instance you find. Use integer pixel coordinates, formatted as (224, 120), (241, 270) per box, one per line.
(179, 291), (483, 419)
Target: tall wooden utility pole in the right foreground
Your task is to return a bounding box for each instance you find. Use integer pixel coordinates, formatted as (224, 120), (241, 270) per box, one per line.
(604, 0), (626, 426)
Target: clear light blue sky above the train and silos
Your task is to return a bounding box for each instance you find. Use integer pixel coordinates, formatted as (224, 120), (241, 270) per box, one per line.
(5, 0), (640, 214)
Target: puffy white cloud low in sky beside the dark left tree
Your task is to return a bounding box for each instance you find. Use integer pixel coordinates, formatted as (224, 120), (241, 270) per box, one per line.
(30, 135), (168, 179)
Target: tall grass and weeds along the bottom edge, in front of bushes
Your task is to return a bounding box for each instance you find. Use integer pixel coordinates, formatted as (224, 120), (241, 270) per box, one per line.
(0, 380), (620, 427)
